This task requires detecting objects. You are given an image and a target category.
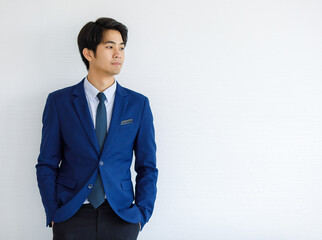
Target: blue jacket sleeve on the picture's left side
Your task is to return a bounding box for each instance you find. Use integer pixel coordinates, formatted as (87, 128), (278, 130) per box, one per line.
(36, 94), (62, 226)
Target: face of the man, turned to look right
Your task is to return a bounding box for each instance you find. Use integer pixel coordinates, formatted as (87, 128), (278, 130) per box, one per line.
(90, 30), (125, 76)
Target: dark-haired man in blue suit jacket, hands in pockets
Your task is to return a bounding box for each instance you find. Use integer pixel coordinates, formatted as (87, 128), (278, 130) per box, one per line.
(36, 18), (158, 240)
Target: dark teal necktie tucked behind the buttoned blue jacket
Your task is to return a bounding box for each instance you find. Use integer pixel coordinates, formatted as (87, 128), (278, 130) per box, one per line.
(88, 92), (107, 208)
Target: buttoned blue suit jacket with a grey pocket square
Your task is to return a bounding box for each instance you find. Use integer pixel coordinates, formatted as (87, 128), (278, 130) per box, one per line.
(36, 79), (158, 228)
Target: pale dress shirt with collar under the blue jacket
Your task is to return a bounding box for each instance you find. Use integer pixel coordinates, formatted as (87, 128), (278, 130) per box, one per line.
(84, 77), (116, 203)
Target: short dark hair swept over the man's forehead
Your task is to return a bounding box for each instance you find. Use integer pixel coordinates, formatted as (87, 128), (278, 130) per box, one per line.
(77, 18), (128, 70)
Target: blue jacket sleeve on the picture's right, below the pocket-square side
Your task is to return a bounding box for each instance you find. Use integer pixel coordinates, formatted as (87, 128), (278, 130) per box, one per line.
(134, 98), (158, 229)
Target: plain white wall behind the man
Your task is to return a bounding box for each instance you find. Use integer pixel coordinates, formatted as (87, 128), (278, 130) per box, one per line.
(0, 0), (322, 240)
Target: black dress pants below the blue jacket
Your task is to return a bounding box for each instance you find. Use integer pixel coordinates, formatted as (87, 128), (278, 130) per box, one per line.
(53, 199), (140, 240)
